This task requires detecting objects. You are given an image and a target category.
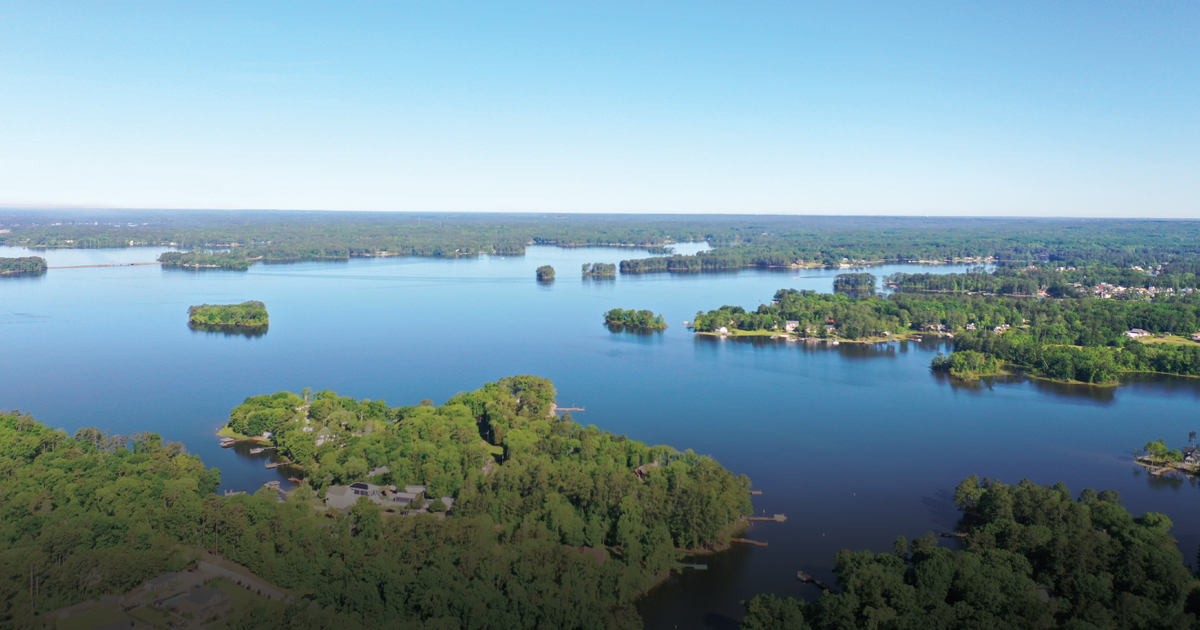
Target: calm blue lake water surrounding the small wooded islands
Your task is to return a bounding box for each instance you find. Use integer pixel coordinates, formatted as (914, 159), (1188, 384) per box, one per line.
(0, 246), (1200, 629)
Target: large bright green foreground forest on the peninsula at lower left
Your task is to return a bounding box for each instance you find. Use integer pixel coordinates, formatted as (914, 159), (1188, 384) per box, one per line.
(0, 377), (750, 630)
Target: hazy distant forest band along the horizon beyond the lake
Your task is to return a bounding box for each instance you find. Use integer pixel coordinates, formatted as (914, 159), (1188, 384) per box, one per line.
(7, 210), (1200, 274)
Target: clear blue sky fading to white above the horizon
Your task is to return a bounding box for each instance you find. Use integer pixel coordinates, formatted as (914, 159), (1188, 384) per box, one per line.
(0, 1), (1200, 217)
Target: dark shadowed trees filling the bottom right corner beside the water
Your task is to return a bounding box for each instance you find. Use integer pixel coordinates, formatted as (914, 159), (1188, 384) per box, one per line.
(742, 475), (1200, 630)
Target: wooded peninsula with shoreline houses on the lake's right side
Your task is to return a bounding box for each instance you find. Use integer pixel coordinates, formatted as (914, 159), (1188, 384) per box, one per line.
(692, 289), (1200, 383)
